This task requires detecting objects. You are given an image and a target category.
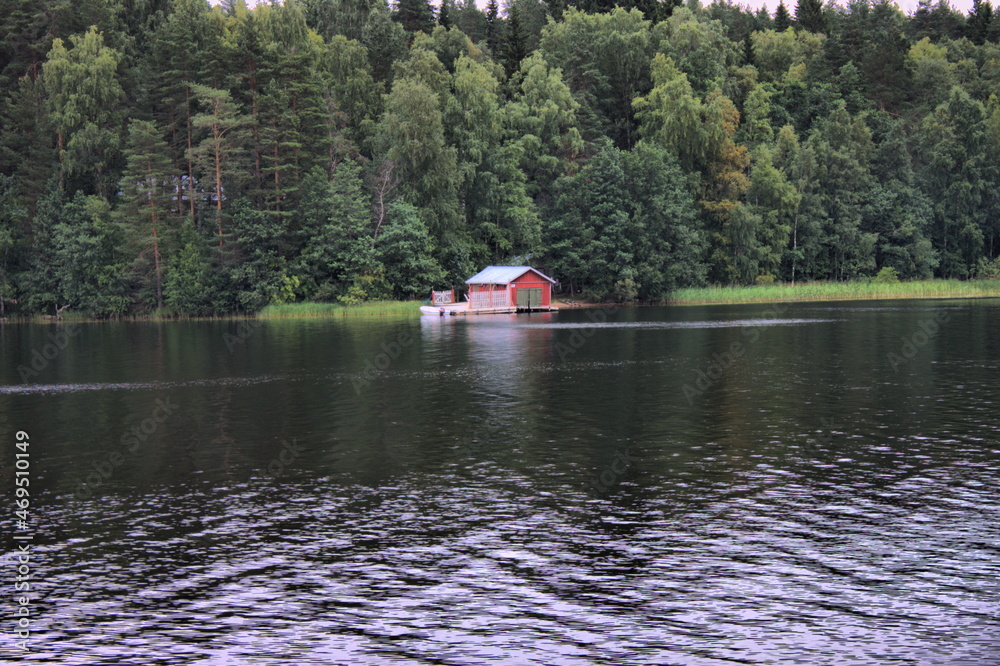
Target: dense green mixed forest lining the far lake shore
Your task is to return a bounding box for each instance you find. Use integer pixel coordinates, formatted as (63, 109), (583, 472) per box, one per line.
(0, 0), (1000, 317)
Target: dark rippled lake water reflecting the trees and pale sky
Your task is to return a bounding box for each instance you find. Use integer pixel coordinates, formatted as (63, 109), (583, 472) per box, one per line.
(0, 300), (1000, 666)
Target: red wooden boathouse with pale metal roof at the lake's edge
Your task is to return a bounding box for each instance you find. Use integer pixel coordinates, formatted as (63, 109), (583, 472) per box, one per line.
(465, 266), (556, 312)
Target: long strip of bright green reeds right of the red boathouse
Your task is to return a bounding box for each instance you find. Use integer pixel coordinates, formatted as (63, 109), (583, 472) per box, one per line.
(669, 280), (1000, 305)
